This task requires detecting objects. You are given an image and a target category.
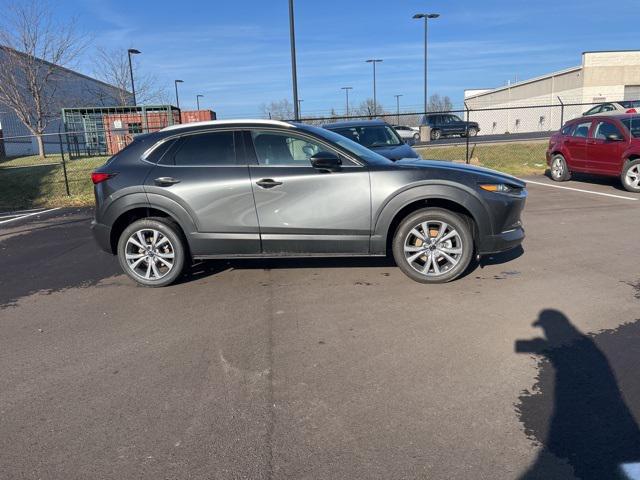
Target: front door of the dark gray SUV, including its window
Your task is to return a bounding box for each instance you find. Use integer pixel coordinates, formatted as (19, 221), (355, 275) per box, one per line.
(245, 129), (371, 255)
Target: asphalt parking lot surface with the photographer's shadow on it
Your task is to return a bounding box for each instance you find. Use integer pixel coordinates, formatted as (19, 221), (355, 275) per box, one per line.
(0, 177), (640, 480)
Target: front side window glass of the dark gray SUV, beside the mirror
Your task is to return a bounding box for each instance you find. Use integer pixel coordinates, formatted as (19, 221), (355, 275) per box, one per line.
(251, 130), (326, 167)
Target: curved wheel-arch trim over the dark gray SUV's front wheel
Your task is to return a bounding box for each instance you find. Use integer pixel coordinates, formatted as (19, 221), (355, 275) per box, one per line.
(371, 180), (493, 254)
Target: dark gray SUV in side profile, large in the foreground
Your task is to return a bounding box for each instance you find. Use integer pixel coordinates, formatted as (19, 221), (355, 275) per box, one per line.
(92, 120), (526, 286)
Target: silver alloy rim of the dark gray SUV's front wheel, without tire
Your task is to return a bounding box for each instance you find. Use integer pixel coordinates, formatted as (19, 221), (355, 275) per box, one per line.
(404, 220), (463, 277)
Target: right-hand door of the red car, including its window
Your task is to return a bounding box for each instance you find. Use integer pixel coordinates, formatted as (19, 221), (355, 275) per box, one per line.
(587, 120), (627, 175)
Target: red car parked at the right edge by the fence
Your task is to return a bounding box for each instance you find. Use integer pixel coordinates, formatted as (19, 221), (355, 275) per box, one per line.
(547, 114), (640, 193)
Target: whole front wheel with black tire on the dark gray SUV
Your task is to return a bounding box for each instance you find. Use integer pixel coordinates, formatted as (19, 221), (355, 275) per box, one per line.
(392, 208), (474, 283)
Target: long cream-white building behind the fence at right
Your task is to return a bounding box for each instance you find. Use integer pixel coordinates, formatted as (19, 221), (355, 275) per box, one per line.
(464, 50), (640, 134)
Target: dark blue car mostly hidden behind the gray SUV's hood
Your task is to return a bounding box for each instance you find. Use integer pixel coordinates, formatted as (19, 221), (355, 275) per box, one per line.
(323, 120), (420, 161)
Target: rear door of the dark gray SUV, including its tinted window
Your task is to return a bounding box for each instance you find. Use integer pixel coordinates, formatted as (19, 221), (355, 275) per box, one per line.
(145, 129), (260, 255)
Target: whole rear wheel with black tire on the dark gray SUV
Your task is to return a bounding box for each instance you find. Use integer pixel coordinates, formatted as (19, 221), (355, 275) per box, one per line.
(118, 217), (187, 287)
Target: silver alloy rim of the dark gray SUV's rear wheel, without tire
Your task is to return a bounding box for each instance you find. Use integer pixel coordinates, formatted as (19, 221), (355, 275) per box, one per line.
(125, 228), (175, 280)
